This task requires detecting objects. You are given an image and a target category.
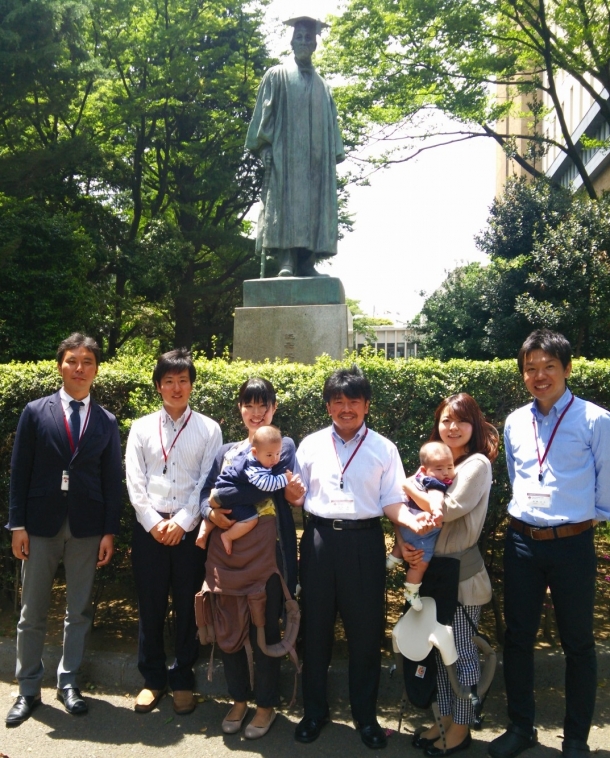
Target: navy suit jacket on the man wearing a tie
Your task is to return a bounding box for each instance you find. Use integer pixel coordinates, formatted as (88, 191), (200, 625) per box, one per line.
(8, 392), (122, 537)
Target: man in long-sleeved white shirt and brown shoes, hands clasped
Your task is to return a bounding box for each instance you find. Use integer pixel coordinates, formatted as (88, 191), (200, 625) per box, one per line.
(125, 349), (222, 715)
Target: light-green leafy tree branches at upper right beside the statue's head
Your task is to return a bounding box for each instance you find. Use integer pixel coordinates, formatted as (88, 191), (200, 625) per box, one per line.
(324, 0), (610, 198)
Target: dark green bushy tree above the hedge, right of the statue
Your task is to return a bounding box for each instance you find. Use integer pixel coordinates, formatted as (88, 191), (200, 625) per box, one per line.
(422, 180), (610, 359)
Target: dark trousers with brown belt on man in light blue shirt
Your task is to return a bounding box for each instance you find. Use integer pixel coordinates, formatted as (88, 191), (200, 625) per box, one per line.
(504, 528), (597, 742)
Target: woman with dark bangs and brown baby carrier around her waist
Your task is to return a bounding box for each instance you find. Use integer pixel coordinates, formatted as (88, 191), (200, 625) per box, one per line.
(197, 378), (304, 739)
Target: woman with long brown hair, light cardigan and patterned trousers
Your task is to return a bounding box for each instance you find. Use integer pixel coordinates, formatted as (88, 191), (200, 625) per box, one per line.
(403, 392), (498, 758)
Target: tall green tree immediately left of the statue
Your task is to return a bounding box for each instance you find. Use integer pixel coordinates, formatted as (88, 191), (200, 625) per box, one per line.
(92, 0), (269, 354)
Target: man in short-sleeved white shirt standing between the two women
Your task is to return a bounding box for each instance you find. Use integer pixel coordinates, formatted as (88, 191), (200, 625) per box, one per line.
(295, 365), (414, 748)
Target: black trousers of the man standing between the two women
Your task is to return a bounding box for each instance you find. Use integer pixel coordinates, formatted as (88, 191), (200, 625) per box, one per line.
(300, 523), (385, 725)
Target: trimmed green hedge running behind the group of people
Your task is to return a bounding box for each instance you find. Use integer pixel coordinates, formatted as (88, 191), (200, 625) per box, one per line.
(0, 356), (610, 590)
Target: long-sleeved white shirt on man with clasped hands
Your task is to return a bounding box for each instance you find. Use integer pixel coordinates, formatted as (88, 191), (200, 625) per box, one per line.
(125, 407), (222, 532)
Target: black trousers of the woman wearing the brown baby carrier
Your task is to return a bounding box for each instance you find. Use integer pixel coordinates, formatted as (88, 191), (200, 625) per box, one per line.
(221, 574), (284, 708)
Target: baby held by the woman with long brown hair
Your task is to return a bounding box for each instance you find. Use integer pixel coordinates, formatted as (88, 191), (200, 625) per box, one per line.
(386, 442), (455, 611)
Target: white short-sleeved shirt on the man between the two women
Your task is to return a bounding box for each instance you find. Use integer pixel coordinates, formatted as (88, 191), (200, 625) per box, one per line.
(296, 424), (405, 519)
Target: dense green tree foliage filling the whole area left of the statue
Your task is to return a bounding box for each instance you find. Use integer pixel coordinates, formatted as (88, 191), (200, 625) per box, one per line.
(0, 0), (270, 358)
